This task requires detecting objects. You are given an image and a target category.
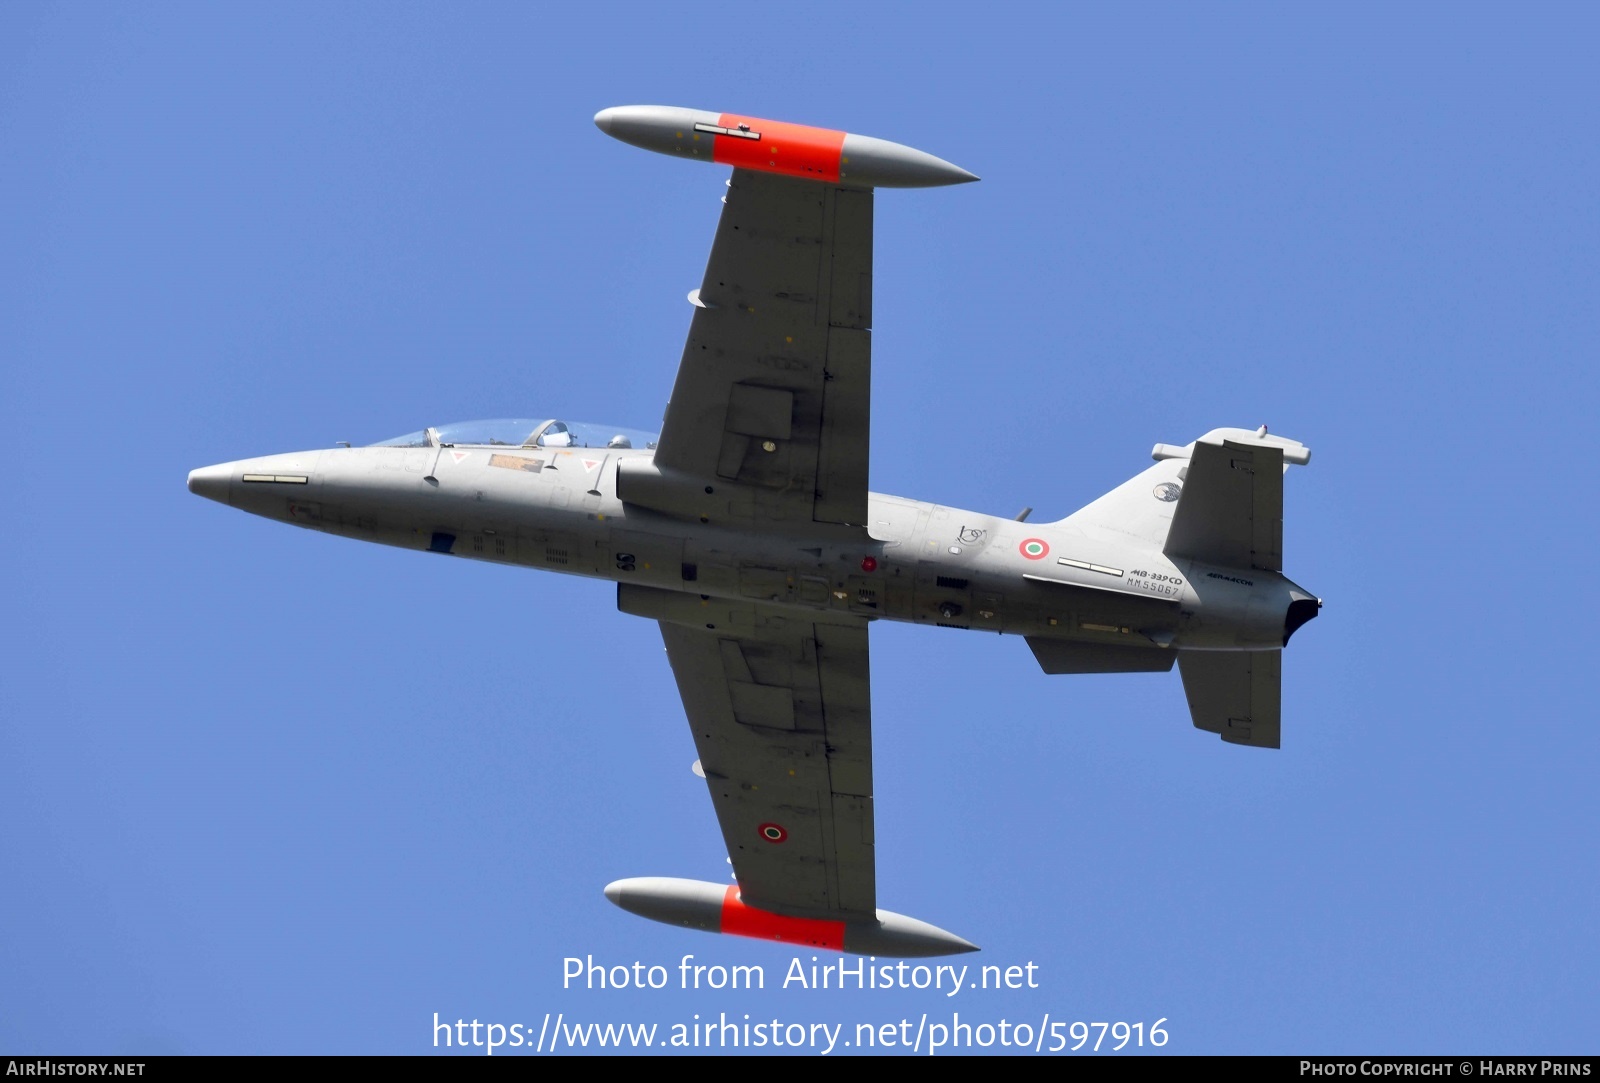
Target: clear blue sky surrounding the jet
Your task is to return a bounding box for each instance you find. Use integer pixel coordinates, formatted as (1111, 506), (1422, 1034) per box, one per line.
(0, 3), (1600, 1054)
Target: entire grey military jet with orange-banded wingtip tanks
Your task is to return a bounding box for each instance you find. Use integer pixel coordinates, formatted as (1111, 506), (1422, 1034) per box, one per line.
(189, 106), (1322, 957)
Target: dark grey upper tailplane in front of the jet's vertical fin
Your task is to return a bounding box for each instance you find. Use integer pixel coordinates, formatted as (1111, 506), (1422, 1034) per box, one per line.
(1163, 434), (1285, 571)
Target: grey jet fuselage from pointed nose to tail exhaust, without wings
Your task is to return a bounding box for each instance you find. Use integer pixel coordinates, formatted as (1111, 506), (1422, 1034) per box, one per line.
(189, 446), (1309, 651)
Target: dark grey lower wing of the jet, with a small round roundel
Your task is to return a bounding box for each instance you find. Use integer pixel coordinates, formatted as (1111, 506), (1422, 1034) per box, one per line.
(661, 601), (877, 921)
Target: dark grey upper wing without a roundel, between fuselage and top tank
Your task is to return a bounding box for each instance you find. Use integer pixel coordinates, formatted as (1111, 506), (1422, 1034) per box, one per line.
(656, 170), (872, 528)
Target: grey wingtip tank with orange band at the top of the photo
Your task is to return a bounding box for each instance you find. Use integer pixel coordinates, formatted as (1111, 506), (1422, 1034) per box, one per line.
(595, 106), (978, 189)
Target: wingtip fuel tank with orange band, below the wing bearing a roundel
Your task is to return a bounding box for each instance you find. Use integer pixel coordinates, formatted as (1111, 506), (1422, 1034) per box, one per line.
(605, 877), (978, 958)
